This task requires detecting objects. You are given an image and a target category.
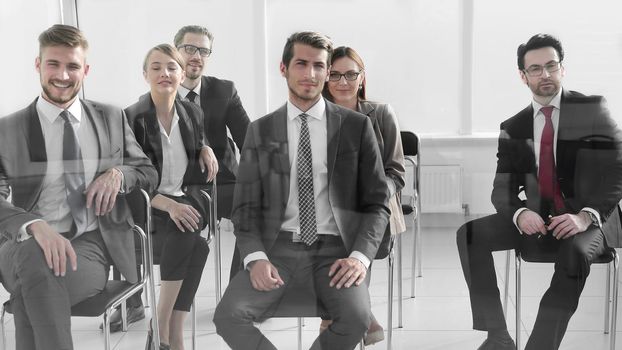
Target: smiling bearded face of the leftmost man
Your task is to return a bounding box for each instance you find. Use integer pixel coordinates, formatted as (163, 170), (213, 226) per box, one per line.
(35, 45), (89, 109)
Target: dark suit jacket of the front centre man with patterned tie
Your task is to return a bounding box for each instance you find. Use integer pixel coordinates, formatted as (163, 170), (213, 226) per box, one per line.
(232, 101), (389, 260)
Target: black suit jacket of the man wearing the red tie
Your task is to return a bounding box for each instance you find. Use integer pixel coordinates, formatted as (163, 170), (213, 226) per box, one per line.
(492, 90), (622, 247)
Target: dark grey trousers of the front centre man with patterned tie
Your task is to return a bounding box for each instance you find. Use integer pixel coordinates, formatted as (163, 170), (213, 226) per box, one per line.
(214, 233), (371, 350)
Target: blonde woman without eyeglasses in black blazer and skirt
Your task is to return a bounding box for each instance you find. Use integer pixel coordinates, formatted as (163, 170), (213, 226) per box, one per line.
(125, 44), (209, 350)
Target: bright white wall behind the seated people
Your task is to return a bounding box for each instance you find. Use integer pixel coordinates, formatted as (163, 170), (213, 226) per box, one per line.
(0, 0), (622, 213)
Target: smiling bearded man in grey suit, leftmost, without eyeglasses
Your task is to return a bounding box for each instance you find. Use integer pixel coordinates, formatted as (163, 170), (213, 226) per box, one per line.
(0, 24), (157, 350)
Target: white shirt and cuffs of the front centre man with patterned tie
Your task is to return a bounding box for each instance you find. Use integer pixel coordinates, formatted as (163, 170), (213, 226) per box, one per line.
(244, 98), (371, 267)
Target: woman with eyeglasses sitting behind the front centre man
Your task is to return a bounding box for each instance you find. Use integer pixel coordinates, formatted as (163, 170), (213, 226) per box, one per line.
(320, 46), (406, 345)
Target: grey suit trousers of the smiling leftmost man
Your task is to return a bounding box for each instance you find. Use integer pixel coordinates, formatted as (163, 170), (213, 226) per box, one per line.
(0, 230), (110, 350)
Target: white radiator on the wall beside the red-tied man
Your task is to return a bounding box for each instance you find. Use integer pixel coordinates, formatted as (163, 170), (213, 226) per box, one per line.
(420, 165), (463, 213)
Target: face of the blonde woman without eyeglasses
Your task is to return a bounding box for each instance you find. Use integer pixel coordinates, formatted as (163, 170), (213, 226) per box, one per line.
(143, 50), (184, 96)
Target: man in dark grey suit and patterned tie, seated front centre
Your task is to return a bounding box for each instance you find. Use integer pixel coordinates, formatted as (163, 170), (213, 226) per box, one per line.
(214, 32), (389, 350)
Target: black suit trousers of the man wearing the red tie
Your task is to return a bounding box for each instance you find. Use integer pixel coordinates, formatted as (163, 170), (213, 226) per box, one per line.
(457, 214), (606, 350)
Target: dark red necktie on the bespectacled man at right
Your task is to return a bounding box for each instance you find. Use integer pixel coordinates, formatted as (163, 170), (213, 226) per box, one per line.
(538, 106), (564, 213)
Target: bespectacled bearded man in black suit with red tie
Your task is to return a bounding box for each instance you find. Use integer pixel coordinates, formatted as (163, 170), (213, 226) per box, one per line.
(457, 34), (622, 350)
